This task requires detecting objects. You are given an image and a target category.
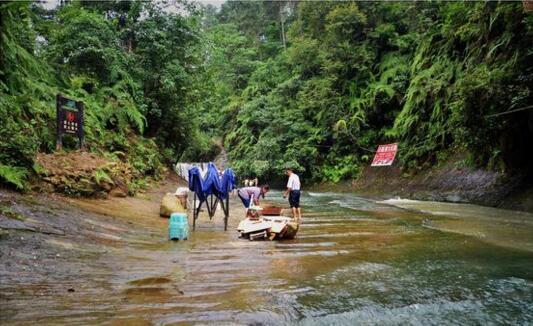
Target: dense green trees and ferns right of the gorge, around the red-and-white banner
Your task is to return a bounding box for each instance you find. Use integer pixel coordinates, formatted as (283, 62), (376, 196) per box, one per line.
(197, 2), (533, 181)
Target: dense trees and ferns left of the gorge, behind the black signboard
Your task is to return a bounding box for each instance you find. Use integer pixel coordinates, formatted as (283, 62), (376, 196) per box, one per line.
(0, 1), (214, 188)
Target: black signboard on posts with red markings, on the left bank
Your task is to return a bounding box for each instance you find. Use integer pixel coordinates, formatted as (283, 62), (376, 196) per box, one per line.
(56, 94), (84, 150)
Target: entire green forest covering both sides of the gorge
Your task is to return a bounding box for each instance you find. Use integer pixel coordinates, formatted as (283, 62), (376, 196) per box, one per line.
(0, 1), (533, 189)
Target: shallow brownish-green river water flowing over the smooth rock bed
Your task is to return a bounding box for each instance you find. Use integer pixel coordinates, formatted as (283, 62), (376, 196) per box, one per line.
(1, 192), (533, 325)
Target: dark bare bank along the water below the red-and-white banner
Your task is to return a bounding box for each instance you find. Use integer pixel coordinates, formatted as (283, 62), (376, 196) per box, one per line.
(312, 160), (533, 212)
